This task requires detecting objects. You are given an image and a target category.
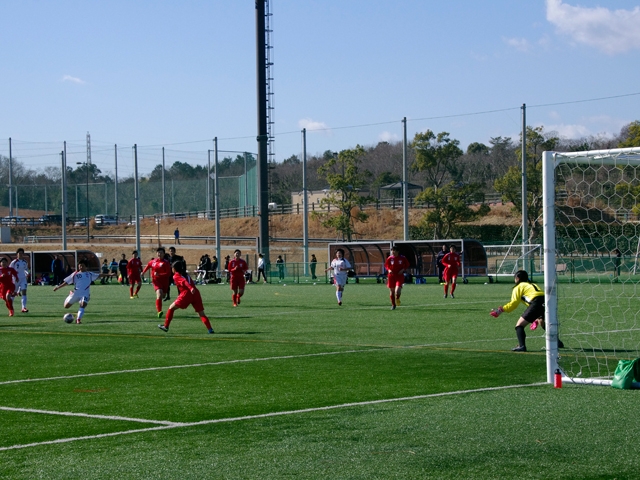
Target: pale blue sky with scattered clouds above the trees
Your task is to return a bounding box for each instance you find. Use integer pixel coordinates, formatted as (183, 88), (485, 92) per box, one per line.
(0, 0), (640, 175)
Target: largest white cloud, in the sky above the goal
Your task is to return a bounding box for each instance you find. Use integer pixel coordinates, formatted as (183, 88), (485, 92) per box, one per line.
(546, 0), (640, 55)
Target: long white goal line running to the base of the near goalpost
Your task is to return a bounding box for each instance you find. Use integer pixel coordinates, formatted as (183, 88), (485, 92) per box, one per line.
(0, 382), (547, 452)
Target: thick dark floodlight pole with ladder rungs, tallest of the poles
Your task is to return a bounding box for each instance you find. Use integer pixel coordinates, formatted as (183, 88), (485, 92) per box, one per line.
(256, 0), (269, 258)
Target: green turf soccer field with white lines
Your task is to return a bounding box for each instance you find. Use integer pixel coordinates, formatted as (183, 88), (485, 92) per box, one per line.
(0, 283), (640, 479)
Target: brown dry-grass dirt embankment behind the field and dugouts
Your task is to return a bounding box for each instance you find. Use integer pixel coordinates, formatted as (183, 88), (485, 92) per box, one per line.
(0, 205), (520, 264)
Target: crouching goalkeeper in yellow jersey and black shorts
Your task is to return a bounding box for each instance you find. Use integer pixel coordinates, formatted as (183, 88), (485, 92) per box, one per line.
(490, 270), (564, 352)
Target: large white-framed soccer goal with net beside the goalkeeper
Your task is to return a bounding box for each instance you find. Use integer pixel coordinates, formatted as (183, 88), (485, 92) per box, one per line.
(542, 148), (640, 386)
